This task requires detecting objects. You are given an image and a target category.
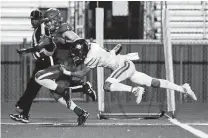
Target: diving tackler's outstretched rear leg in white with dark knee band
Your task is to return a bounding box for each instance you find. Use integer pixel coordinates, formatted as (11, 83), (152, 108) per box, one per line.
(130, 71), (197, 100)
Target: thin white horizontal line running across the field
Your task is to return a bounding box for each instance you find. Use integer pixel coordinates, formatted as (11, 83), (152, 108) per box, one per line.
(1, 122), (208, 126)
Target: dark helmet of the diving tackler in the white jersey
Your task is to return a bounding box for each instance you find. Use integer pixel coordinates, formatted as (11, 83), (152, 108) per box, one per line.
(70, 39), (89, 66)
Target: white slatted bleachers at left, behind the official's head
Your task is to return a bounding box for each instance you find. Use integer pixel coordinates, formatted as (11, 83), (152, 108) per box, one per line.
(1, 1), (69, 43)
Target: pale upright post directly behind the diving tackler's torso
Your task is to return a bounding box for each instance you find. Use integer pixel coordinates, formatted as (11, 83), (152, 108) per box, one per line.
(96, 8), (104, 113)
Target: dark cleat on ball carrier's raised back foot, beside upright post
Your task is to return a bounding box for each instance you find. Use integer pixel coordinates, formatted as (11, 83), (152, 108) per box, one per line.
(84, 82), (97, 101)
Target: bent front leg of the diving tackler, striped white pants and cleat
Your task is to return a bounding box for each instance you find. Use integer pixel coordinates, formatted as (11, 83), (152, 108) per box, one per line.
(104, 61), (144, 103)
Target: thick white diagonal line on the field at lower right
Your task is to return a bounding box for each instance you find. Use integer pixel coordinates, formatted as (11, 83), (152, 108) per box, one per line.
(168, 117), (208, 138)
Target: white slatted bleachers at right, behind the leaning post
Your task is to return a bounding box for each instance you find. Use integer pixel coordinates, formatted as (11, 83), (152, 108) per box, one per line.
(153, 1), (208, 40)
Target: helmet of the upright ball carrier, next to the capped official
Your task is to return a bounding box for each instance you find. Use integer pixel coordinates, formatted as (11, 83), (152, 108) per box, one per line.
(43, 8), (63, 31)
